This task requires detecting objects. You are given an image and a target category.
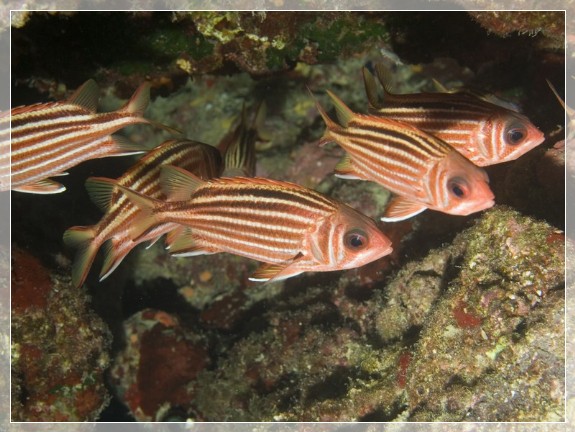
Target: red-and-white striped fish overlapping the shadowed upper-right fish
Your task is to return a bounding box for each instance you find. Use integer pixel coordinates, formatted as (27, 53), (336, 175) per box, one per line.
(317, 91), (494, 221)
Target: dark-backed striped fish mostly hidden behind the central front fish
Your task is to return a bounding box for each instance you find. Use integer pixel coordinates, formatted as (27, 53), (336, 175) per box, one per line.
(64, 139), (223, 286)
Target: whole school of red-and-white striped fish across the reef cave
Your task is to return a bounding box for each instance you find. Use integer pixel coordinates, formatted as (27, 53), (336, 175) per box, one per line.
(7, 61), (544, 286)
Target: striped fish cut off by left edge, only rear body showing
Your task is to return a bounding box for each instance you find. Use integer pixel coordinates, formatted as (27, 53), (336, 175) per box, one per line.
(0, 80), (174, 194)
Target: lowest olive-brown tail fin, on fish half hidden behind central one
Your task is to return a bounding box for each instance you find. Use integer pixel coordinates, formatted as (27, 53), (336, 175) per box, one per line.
(64, 226), (100, 287)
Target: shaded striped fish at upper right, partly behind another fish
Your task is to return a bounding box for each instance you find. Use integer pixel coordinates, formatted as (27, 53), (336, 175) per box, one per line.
(363, 64), (545, 166)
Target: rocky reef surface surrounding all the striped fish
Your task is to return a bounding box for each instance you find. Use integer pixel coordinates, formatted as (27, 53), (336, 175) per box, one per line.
(6, 12), (570, 422)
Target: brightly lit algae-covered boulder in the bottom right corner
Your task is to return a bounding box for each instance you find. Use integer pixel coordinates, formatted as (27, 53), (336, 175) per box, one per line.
(406, 209), (565, 421)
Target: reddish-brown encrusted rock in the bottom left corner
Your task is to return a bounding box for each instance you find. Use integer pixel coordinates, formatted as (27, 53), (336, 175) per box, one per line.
(12, 249), (110, 422)
